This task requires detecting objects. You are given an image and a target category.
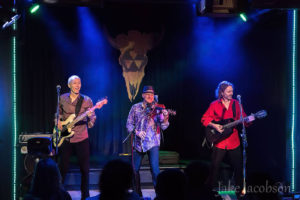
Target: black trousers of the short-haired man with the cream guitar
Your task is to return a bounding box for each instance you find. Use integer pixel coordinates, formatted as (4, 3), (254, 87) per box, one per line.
(59, 139), (90, 199)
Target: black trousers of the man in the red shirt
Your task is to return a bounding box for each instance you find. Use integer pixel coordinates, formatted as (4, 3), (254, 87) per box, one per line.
(206, 146), (243, 193)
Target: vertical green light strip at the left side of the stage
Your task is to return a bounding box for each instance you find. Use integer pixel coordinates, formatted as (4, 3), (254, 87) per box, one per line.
(12, 14), (17, 200)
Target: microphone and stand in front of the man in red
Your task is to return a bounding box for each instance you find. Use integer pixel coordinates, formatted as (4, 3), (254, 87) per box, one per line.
(237, 95), (248, 195)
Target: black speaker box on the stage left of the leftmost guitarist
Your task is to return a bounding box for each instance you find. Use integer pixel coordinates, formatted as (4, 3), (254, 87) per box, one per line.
(27, 137), (52, 156)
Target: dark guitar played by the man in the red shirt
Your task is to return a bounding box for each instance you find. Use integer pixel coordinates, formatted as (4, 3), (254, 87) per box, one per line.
(205, 110), (267, 144)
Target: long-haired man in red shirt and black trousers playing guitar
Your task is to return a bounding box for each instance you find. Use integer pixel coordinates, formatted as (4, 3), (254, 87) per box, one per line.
(201, 81), (254, 199)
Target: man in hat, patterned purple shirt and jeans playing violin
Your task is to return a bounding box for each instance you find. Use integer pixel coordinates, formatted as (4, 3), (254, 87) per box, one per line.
(126, 86), (169, 197)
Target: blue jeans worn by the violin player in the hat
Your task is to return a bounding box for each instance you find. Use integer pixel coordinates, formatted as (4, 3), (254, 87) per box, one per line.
(133, 146), (159, 196)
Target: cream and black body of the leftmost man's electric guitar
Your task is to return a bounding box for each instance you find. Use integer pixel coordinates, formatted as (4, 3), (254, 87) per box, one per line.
(53, 114), (76, 147)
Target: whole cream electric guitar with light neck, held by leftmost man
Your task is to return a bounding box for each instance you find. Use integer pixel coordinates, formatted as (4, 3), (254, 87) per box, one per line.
(52, 98), (107, 147)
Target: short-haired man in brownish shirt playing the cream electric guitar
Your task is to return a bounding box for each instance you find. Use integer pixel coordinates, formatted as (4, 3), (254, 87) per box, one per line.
(57, 75), (96, 199)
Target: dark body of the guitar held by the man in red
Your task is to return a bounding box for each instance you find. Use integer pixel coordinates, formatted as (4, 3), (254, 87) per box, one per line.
(205, 119), (234, 144)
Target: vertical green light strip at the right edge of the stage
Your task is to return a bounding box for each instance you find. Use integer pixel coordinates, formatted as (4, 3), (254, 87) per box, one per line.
(291, 10), (298, 192)
